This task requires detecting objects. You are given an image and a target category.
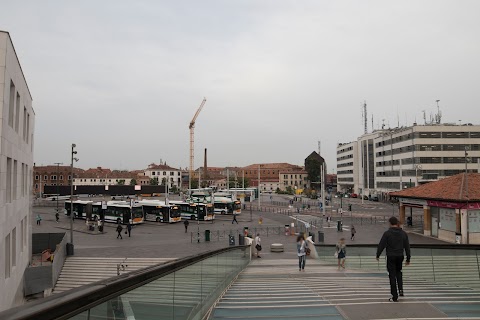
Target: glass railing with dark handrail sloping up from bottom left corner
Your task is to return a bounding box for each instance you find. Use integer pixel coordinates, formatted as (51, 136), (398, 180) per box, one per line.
(0, 246), (251, 320)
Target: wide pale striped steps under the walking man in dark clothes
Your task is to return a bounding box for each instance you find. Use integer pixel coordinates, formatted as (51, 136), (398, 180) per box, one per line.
(209, 258), (480, 320)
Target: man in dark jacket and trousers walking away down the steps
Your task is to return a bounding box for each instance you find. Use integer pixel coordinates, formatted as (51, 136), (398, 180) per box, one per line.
(377, 217), (410, 302)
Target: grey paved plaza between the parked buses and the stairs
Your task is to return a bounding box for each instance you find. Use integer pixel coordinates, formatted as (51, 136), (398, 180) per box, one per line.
(32, 195), (444, 259)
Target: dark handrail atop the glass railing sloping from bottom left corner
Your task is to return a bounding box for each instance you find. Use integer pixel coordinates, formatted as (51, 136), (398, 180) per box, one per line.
(0, 246), (249, 320)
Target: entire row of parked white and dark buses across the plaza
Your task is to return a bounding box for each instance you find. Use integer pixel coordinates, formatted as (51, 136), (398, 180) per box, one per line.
(64, 196), (241, 224)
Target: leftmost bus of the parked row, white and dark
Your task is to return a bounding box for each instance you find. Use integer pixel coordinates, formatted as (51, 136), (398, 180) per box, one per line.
(64, 200), (144, 224)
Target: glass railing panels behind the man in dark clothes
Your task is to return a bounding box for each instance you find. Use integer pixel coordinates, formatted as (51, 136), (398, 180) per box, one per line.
(315, 244), (480, 289)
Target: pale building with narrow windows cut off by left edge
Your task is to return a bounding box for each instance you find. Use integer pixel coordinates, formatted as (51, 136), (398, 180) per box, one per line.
(0, 31), (35, 310)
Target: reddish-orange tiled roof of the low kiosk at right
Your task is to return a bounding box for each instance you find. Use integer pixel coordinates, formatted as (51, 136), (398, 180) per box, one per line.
(390, 173), (480, 201)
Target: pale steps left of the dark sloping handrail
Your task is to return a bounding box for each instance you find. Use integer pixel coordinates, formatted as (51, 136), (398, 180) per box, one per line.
(53, 256), (173, 293)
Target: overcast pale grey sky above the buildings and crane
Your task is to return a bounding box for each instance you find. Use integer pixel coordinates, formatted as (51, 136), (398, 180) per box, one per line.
(0, 0), (480, 172)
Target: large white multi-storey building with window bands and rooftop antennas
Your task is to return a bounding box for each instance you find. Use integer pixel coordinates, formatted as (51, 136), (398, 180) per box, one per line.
(337, 123), (480, 196)
